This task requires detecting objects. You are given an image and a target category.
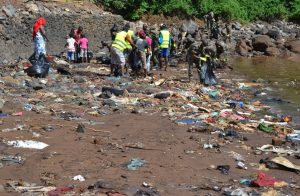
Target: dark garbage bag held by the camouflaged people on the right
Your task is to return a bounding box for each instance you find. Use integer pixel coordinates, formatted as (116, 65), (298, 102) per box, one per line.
(200, 62), (217, 86)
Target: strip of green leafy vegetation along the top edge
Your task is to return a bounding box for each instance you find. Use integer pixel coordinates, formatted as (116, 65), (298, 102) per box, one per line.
(94, 0), (300, 21)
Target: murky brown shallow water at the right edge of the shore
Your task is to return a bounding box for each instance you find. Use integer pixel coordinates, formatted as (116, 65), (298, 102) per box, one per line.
(231, 57), (300, 124)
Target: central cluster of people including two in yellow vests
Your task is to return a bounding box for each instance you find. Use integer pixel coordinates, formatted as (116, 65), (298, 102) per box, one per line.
(110, 23), (171, 77)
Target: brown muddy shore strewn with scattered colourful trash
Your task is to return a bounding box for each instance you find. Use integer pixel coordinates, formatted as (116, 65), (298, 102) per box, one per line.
(0, 58), (300, 196)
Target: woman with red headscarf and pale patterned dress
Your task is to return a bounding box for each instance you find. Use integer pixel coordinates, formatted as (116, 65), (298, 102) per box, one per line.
(32, 18), (48, 59)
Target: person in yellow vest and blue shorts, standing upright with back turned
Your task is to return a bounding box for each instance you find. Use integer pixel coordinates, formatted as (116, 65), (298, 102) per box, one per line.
(158, 24), (171, 71)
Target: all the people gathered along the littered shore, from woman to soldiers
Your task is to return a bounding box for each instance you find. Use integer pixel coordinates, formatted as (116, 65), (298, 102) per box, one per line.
(33, 13), (230, 85)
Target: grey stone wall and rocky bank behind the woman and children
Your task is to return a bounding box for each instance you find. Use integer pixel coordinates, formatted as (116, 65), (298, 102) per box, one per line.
(0, 1), (124, 64)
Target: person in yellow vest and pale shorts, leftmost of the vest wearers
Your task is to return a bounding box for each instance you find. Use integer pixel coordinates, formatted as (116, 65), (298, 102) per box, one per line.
(110, 25), (134, 76)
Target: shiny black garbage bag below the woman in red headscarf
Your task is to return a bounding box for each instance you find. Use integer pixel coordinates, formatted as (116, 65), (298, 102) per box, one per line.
(26, 54), (50, 78)
